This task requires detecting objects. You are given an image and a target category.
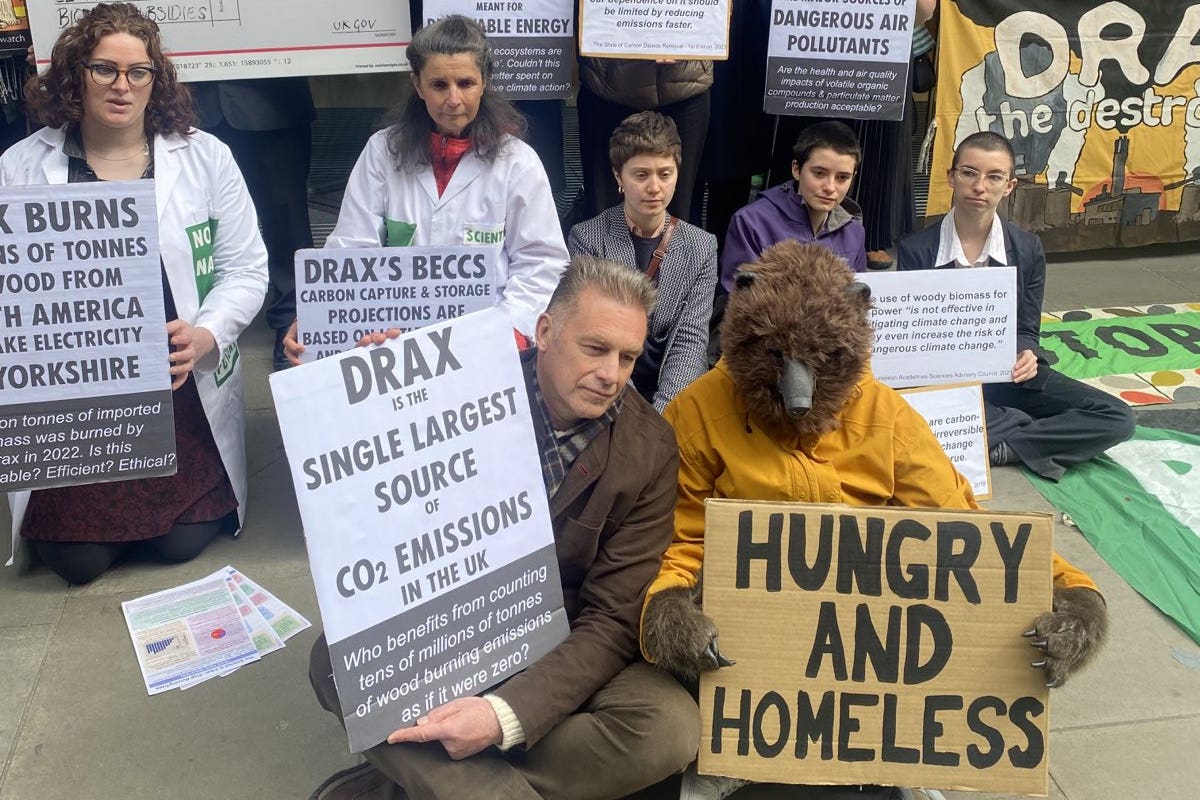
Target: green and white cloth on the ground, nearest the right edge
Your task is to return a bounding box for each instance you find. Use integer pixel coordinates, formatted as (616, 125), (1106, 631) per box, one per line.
(1026, 427), (1200, 643)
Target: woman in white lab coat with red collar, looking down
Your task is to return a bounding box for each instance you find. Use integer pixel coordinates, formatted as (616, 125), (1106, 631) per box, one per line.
(284, 14), (570, 363)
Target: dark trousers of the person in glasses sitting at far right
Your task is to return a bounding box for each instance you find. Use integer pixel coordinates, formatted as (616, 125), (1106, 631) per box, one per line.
(983, 365), (1134, 481)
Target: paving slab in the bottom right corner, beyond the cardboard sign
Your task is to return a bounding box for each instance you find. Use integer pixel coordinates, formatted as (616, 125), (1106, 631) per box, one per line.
(1050, 714), (1200, 800)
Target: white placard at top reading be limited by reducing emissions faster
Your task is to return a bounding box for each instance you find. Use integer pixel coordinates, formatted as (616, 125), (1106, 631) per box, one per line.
(580, 0), (730, 61)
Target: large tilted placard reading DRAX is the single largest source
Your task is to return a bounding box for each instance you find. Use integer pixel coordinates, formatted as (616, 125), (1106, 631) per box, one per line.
(271, 308), (569, 752)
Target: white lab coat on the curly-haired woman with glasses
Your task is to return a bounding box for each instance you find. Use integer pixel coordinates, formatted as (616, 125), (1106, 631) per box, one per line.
(0, 128), (266, 553)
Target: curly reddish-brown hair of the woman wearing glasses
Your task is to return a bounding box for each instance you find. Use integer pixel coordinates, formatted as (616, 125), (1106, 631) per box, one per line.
(25, 2), (196, 134)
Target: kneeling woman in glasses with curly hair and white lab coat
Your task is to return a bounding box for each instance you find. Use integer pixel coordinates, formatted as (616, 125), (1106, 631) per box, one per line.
(0, 4), (266, 584)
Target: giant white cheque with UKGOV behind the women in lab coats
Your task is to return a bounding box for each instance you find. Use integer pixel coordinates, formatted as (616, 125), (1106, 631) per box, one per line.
(29, 0), (412, 80)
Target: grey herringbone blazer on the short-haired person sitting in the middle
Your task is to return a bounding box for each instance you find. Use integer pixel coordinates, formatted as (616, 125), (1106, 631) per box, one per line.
(566, 205), (716, 411)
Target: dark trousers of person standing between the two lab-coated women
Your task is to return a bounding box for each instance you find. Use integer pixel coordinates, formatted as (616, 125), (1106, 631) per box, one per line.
(209, 121), (312, 331)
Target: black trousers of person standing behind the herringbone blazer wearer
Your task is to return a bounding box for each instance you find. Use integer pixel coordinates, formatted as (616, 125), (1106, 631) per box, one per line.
(578, 86), (709, 223)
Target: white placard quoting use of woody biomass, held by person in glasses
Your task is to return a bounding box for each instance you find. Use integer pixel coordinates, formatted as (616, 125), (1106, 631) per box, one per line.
(858, 266), (1016, 389)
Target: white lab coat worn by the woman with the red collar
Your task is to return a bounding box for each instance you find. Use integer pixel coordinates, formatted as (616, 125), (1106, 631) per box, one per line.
(325, 130), (570, 335)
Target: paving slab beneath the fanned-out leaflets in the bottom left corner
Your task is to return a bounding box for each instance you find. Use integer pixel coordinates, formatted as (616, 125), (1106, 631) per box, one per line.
(0, 578), (356, 800)
